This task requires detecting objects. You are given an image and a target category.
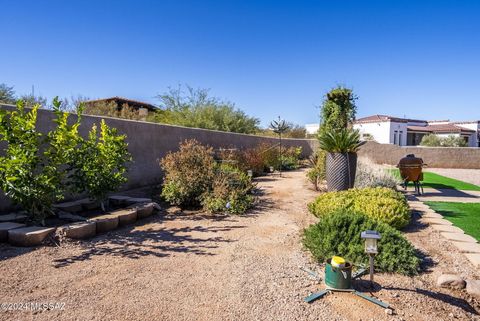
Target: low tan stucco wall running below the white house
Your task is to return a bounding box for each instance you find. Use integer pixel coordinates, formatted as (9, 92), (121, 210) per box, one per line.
(358, 142), (480, 169)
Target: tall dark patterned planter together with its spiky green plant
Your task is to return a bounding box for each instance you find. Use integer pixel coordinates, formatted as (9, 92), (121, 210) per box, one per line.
(319, 128), (363, 191)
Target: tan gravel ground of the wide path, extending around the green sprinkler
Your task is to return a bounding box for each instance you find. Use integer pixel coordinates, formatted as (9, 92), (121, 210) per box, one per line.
(0, 170), (480, 321)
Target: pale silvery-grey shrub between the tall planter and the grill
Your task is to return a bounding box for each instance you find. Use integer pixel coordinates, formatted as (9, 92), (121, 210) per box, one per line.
(355, 159), (401, 190)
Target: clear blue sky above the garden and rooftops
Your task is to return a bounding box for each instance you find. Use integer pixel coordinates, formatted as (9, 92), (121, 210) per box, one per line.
(0, 0), (480, 125)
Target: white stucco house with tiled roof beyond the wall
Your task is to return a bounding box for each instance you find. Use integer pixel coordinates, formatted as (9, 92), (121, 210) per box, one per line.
(353, 115), (480, 147)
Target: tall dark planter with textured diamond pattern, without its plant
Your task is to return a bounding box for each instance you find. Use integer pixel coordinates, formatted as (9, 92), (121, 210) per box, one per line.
(326, 153), (357, 192)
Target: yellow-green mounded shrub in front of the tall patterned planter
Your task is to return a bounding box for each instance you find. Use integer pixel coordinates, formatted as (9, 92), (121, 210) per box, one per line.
(308, 187), (410, 229)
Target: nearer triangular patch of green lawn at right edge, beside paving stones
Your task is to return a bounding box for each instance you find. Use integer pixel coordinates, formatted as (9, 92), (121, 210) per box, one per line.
(425, 202), (480, 241)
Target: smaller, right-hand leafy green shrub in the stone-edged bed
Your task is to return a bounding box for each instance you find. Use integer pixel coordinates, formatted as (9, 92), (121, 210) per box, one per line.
(71, 119), (132, 210)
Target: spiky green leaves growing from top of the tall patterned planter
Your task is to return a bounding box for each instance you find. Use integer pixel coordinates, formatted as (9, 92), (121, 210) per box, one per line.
(318, 128), (365, 153)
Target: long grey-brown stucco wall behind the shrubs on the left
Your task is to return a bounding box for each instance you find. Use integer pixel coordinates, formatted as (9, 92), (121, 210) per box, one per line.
(0, 105), (317, 211)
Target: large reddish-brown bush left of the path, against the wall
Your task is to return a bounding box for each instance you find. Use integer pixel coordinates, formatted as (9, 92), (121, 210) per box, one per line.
(160, 139), (215, 207)
